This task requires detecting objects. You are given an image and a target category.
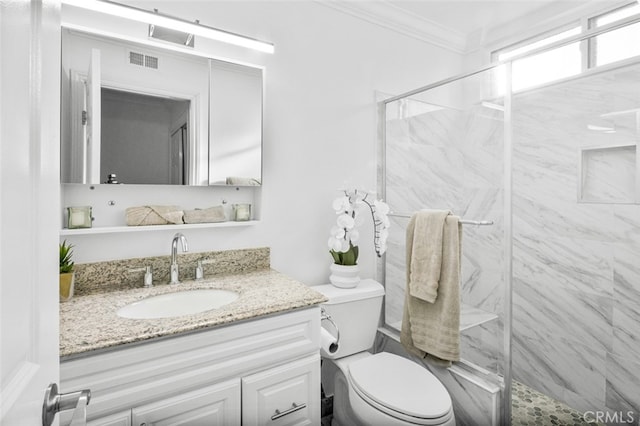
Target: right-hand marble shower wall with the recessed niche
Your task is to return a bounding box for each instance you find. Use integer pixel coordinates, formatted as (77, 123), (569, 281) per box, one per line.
(512, 61), (640, 422)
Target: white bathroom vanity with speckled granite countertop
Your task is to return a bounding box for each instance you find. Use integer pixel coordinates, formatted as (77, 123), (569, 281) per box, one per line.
(60, 269), (325, 425)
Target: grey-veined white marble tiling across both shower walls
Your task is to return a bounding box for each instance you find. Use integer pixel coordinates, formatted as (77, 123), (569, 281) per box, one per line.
(385, 60), (640, 421)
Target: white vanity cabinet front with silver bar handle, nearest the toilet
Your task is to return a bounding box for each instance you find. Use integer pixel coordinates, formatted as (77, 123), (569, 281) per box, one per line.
(242, 355), (320, 426)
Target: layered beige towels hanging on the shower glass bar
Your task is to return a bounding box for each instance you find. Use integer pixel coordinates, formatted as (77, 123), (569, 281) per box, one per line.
(400, 210), (462, 365)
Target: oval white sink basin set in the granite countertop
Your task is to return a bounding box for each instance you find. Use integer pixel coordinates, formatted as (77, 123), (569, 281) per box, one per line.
(116, 289), (238, 319)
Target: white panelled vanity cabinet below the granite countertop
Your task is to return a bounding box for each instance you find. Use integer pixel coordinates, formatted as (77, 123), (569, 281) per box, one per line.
(60, 306), (320, 426)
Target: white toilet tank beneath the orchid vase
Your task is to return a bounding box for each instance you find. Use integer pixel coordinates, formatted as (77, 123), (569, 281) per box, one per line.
(313, 279), (384, 359)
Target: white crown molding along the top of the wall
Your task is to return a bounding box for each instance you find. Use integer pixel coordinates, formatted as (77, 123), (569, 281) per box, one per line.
(315, 0), (467, 54)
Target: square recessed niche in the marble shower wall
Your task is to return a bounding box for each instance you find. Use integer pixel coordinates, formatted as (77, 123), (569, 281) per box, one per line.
(578, 143), (640, 204)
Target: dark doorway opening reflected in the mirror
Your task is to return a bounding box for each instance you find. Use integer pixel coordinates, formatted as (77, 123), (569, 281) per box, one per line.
(100, 87), (190, 185)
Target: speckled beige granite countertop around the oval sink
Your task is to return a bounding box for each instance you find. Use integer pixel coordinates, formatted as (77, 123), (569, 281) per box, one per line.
(60, 269), (327, 357)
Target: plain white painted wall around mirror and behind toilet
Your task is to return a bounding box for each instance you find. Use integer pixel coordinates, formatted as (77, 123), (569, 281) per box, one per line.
(63, 1), (462, 284)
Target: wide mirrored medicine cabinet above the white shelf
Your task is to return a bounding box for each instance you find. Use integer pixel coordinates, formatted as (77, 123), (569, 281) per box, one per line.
(61, 28), (263, 186)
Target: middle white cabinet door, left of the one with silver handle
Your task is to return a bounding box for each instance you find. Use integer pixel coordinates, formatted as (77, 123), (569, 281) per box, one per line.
(131, 379), (240, 426)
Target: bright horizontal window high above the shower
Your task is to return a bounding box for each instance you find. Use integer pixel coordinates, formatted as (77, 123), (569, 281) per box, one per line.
(493, 1), (640, 92)
